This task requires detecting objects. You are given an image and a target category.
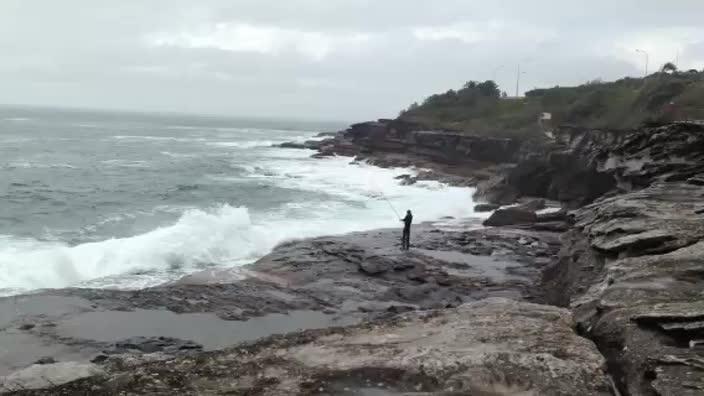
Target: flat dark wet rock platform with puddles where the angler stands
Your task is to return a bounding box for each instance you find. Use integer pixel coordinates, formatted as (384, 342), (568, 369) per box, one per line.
(0, 222), (576, 394)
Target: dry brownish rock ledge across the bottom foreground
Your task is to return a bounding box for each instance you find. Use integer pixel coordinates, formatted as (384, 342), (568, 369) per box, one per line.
(6, 298), (611, 395)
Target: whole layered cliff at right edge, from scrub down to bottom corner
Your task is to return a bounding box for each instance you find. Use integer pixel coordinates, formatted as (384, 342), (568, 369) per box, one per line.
(532, 124), (704, 395)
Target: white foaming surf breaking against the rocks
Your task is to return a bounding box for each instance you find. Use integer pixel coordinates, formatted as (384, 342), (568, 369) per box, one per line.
(0, 153), (474, 294)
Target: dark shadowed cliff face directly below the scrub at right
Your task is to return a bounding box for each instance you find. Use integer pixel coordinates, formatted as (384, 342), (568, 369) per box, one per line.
(477, 123), (704, 208)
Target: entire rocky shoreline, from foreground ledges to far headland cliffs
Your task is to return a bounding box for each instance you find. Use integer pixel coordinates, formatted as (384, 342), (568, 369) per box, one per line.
(0, 120), (704, 396)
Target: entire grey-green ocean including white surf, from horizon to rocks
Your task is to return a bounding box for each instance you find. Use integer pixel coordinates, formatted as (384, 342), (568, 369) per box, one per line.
(0, 108), (473, 296)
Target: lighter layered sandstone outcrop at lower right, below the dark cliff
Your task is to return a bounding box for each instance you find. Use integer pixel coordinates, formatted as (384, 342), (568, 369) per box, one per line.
(546, 181), (704, 395)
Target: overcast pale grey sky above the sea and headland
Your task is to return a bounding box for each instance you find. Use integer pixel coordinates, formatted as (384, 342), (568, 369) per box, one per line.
(0, 0), (704, 121)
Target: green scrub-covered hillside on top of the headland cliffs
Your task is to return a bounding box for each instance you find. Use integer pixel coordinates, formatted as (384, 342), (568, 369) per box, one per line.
(399, 71), (704, 138)
